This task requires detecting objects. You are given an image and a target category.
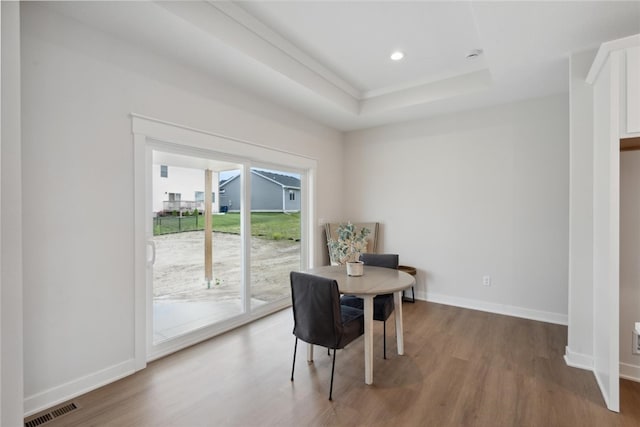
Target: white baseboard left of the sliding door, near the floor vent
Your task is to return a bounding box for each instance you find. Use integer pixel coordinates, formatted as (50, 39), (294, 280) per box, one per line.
(24, 359), (135, 417)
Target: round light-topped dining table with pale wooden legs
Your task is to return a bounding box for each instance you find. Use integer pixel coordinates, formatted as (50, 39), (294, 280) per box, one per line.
(306, 265), (416, 384)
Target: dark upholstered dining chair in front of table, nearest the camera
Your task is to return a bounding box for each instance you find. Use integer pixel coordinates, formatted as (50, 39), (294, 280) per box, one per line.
(290, 271), (364, 400)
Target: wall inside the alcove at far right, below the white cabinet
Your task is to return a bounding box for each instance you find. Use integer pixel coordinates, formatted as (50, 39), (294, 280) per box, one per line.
(620, 151), (640, 381)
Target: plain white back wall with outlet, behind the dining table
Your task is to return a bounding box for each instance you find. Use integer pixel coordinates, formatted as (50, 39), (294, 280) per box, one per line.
(344, 95), (569, 323)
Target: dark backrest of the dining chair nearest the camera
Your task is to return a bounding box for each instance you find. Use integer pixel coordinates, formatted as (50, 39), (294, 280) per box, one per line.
(290, 271), (343, 348)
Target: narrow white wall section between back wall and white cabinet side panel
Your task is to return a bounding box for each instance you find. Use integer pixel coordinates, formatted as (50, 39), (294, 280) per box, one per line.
(566, 49), (596, 369)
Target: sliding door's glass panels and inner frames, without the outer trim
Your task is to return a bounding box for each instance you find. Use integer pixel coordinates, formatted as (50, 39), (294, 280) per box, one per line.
(147, 143), (305, 358)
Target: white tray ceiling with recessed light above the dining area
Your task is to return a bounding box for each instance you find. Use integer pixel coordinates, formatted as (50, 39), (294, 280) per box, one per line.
(47, 1), (640, 130)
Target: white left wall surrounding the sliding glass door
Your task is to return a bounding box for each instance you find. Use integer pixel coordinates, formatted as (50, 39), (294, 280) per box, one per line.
(22, 3), (344, 413)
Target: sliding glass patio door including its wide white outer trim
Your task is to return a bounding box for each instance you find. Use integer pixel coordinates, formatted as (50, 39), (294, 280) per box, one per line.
(131, 114), (316, 362)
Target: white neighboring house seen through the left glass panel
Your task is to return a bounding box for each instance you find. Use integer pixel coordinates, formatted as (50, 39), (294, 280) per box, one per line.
(153, 165), (219, 213)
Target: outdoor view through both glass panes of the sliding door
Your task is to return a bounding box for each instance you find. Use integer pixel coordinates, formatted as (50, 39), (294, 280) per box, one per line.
(153, 155), (301, 343)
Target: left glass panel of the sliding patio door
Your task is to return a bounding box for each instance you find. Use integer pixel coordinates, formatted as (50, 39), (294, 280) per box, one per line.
(152, 150), (244, 345)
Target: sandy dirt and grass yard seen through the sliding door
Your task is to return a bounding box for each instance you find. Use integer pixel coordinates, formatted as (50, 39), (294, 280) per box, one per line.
(153, 212), (300, 304)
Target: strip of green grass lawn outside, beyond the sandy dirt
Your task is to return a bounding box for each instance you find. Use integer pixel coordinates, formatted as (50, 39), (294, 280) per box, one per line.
(153, 212), (300, 240)
